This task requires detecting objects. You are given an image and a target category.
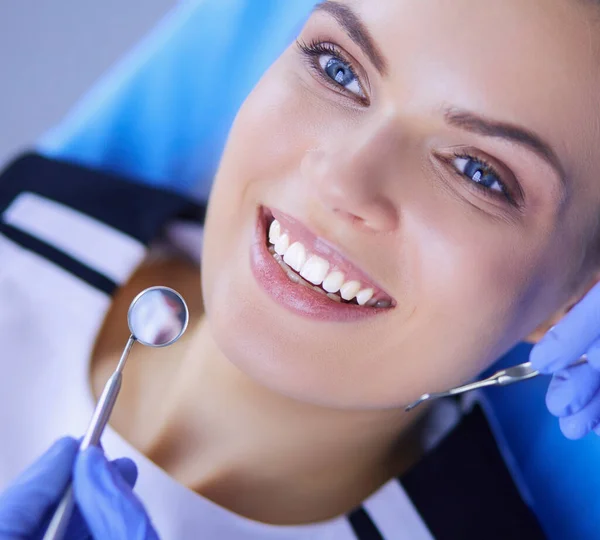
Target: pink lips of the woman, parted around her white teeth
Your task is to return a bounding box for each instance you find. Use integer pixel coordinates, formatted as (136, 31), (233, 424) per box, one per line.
(250, 208), (391, 322)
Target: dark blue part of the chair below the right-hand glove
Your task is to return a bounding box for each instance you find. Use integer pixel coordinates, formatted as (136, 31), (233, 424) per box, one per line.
(483, 344), (600, 540)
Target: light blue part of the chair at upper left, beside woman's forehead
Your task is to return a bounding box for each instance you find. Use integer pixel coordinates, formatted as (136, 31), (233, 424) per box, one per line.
(38, 0), (316, 197)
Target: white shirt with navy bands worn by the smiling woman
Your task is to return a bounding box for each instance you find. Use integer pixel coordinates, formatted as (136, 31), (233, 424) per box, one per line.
(0, 156), (433, 540)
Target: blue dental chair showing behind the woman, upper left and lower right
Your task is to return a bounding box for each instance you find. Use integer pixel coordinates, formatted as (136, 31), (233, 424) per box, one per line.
(37, 0), (600, 540)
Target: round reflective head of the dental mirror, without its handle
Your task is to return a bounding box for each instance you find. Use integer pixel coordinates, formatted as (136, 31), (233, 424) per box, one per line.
(127, 287), (189, 347)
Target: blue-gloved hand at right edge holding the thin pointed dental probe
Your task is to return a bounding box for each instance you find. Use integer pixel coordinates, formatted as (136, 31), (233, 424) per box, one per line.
(530, 284), (600, 439)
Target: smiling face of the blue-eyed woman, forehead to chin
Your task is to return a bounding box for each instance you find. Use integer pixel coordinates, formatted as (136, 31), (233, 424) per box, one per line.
(203, 0), (600, 408)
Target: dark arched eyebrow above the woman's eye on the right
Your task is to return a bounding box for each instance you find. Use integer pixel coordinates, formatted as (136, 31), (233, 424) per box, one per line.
(444, 108), (567, 187)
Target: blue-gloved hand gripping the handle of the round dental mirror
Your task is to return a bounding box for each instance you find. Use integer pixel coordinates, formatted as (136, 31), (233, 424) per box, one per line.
(0, 437), (158, 540)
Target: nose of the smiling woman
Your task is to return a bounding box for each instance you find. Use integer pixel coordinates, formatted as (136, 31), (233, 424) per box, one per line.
(302, 116), (400, 233)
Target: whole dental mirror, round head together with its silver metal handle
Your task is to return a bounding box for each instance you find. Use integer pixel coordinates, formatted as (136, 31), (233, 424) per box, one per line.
(43, 287), (189, 540)
